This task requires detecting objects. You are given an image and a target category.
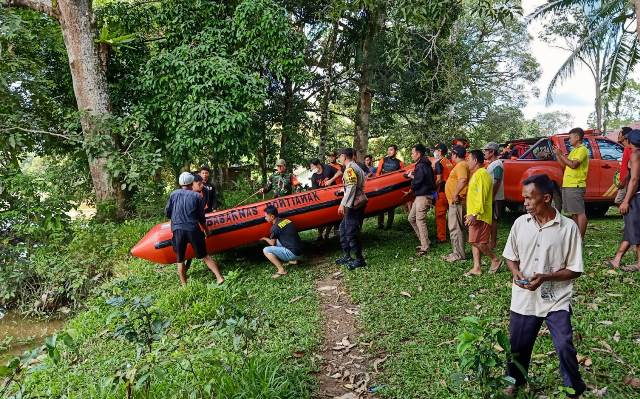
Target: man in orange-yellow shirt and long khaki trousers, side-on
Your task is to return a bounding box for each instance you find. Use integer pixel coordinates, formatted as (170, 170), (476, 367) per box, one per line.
(443, 146), (469, 263)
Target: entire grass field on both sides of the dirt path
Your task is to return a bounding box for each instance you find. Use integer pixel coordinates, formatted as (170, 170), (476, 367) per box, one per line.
(6, 213), (640, 399)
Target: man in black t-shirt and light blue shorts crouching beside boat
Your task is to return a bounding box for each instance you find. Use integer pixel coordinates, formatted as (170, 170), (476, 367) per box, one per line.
(260, 205), (302, 278)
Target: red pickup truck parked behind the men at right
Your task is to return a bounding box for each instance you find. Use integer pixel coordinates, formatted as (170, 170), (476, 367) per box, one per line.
(504, 131), (623, 216)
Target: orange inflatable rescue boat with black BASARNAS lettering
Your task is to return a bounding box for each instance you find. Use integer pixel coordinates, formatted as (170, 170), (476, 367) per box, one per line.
(131, 165), (413, 264)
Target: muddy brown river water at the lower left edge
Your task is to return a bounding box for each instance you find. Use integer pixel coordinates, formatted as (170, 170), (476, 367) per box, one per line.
(0, 312), (64, 365)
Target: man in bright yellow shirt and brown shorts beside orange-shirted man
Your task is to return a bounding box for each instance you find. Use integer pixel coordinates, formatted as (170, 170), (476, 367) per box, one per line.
(465, 150), (501, 276)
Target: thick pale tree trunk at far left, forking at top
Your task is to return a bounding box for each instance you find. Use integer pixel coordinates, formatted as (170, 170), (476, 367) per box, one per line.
(6, 0), (124, 217)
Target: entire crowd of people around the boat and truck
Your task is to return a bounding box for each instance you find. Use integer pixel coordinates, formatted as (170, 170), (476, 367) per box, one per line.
(166, 128), (640, 397)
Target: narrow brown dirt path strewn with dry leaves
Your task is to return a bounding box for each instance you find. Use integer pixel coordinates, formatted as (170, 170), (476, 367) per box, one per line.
(316, 262), (380, 399)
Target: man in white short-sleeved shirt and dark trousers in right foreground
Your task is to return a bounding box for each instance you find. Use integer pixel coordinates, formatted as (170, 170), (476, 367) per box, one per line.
(503, 175), (586, 398)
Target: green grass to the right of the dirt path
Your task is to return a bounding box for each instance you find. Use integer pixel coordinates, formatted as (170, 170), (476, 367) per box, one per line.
(347, 214), (640, 398)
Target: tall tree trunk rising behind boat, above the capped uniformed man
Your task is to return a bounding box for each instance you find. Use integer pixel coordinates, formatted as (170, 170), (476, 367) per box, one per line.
(353, 5), (386, 161)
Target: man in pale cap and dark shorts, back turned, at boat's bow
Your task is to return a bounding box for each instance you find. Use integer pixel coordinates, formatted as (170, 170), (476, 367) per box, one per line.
(165, 172), (224, 286)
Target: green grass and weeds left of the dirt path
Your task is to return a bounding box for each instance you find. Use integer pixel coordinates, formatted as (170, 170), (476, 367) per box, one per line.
(16, 223), (322, 398)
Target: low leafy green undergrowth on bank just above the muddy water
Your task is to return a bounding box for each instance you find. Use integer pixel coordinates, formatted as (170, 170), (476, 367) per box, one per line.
(0, 222), (150, 315)
